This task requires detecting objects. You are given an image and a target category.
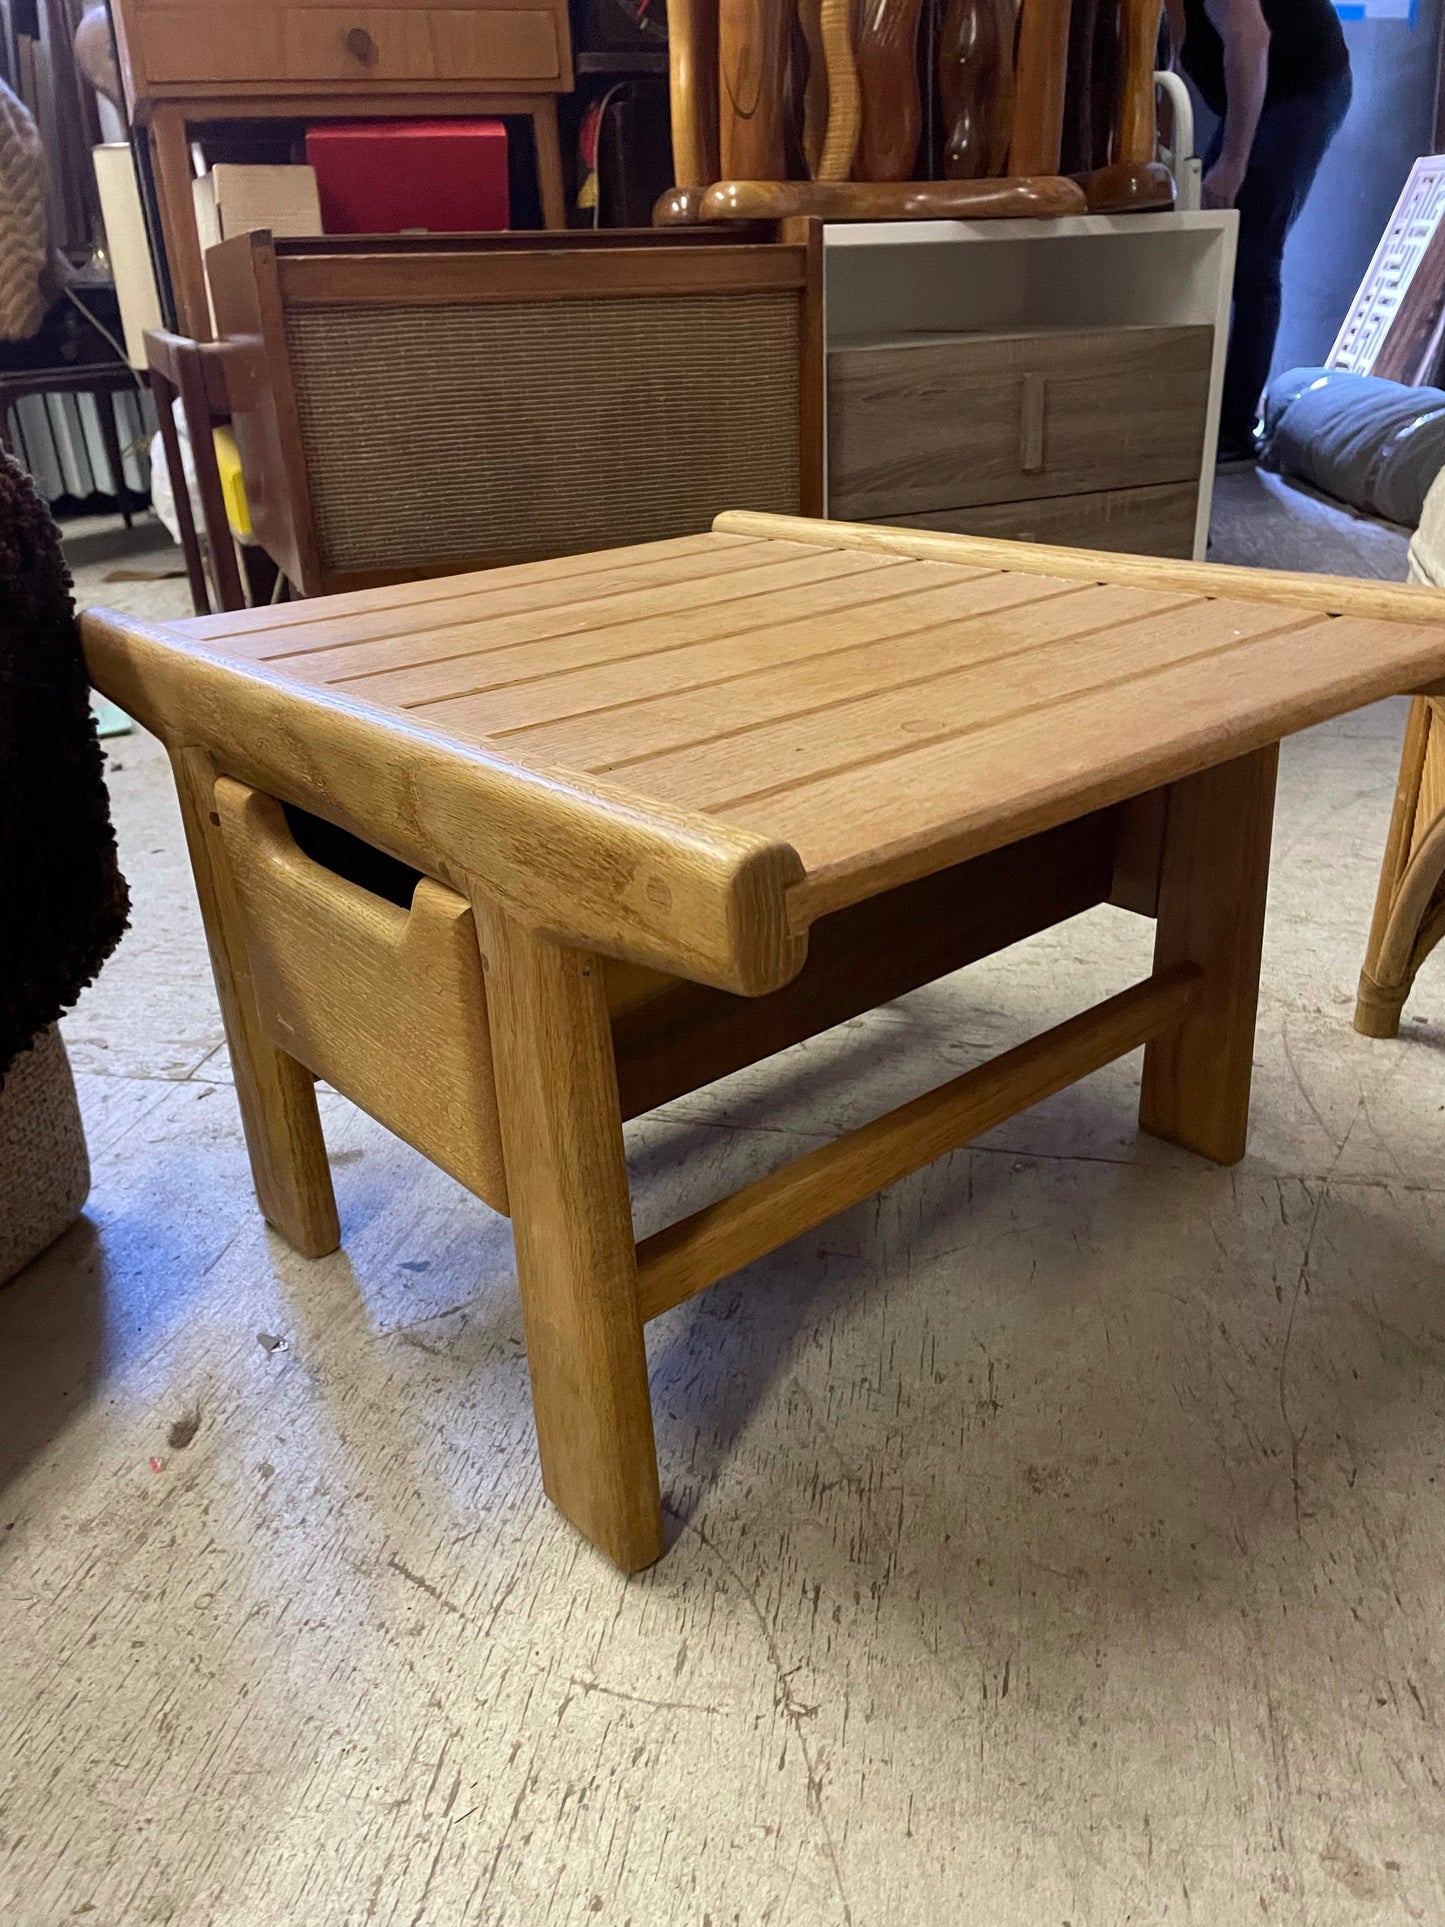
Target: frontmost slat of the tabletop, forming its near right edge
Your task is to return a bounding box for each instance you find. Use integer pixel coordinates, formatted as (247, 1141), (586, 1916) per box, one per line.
(751, 617), (1445, 927)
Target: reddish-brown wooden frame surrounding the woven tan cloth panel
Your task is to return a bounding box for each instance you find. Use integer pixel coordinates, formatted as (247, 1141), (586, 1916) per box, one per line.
(208, 222), (825, 595)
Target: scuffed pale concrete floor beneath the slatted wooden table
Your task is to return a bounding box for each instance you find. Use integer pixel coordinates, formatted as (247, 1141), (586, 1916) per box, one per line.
(0, 512), (1445, 1927)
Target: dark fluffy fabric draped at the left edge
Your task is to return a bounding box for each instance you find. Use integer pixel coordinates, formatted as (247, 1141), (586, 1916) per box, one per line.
(0, 455), (131, 1079)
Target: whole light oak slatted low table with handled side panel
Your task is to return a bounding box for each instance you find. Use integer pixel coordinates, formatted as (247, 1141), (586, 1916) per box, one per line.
(85, 515), (1445, 1571)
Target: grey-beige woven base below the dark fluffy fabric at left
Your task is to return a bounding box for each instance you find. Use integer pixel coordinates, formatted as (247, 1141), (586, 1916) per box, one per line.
(0, 1025), (91, 1285)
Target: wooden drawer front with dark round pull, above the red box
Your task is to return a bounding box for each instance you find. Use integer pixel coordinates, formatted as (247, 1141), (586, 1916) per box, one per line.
(139, 6), (563, 87)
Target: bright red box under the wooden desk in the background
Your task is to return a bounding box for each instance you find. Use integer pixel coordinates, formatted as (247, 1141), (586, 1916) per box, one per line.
(306, 121), (511, 235)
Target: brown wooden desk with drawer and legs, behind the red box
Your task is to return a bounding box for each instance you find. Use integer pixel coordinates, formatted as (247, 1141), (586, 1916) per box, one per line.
(112, 0), (572, 341)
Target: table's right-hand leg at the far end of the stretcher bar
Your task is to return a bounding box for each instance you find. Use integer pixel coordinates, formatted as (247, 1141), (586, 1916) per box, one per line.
(1139, 744), (1279, 1164)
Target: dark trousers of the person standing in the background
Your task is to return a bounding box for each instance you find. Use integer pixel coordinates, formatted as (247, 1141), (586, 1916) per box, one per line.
(1204, 67), (1351, 451)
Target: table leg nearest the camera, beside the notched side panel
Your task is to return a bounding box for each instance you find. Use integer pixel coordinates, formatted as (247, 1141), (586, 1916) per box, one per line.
(474, 900), (663, 1572)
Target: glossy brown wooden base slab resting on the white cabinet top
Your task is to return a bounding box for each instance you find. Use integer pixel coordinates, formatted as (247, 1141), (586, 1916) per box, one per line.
(701, 175), (1087, 222)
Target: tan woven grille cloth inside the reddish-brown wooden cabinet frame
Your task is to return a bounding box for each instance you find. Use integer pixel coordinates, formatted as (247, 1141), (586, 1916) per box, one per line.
(287, 293), (800, 570)
